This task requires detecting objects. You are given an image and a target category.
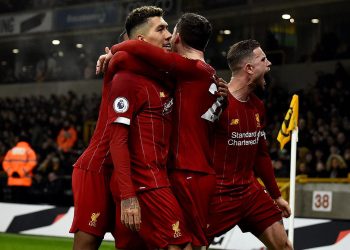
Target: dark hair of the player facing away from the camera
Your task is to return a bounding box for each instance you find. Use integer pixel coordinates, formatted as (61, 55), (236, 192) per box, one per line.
(176, 13), (213, 51)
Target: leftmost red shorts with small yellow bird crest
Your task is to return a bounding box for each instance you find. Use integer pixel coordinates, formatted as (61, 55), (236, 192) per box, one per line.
(69, 168), (115, 237)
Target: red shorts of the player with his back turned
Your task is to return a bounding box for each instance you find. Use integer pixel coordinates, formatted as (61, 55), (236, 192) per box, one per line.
(169, 170), (216, 247)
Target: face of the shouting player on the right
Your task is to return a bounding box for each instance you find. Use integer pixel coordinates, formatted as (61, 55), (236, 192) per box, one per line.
(252, 47), (271, 89)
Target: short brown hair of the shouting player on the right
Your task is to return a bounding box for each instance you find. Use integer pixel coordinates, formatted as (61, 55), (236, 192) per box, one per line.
(227, 39), (260, 72)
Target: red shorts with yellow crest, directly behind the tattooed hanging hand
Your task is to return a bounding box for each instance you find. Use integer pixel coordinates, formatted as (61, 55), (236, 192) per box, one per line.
(113, 187), (191, 249)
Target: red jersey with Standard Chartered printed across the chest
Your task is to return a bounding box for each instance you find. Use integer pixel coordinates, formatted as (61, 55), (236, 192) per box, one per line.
(213, 94), (279, 196)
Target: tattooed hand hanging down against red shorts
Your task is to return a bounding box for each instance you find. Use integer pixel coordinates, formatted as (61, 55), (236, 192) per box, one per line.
(120, 197), (141, 231)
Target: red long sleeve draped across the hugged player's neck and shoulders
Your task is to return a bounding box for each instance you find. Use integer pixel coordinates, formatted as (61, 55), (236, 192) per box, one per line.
(111, 40), (194, 76)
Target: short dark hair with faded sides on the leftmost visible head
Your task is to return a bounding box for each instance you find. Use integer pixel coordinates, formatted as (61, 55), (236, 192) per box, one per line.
(125, 6), (164, 37)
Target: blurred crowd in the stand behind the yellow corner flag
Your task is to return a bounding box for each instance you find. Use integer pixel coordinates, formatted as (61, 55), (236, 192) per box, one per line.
(265, 64), (350, 178)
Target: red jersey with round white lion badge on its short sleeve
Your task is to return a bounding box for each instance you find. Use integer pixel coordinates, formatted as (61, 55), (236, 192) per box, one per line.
(108, 70), (173, 193)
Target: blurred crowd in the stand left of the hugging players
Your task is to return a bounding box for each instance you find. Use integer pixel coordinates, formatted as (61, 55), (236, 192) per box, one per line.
(0, 92), (100, 205)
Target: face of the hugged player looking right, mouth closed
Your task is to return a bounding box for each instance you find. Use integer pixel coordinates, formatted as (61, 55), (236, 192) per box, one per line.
(143, 16), (171, 50)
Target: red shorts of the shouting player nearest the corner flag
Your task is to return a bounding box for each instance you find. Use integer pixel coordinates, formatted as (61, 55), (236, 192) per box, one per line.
(208, 185), (282, 238)
